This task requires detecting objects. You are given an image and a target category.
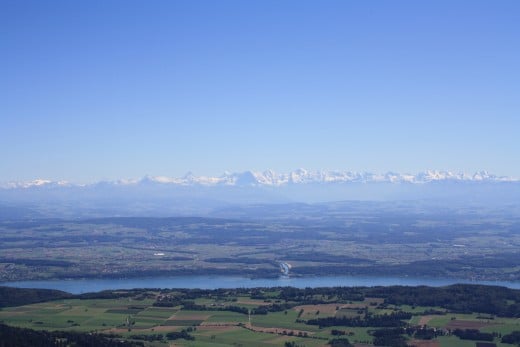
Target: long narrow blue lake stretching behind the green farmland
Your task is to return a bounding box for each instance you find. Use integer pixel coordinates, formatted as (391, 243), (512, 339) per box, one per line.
(4, 276), (520, 294)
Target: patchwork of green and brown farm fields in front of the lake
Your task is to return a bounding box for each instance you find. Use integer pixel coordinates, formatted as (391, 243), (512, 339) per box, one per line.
(0, 285), (520, 347)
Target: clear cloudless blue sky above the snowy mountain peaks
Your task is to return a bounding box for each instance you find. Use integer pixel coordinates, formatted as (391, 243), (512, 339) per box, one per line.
(0, 0), (520, 183)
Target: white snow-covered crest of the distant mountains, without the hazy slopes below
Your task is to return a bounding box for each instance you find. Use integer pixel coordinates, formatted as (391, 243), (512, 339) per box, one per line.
(0, 169), (520, 189)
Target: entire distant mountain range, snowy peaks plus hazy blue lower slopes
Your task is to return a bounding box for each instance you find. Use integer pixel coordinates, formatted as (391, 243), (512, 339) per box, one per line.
(0, 169), (520, 220)
